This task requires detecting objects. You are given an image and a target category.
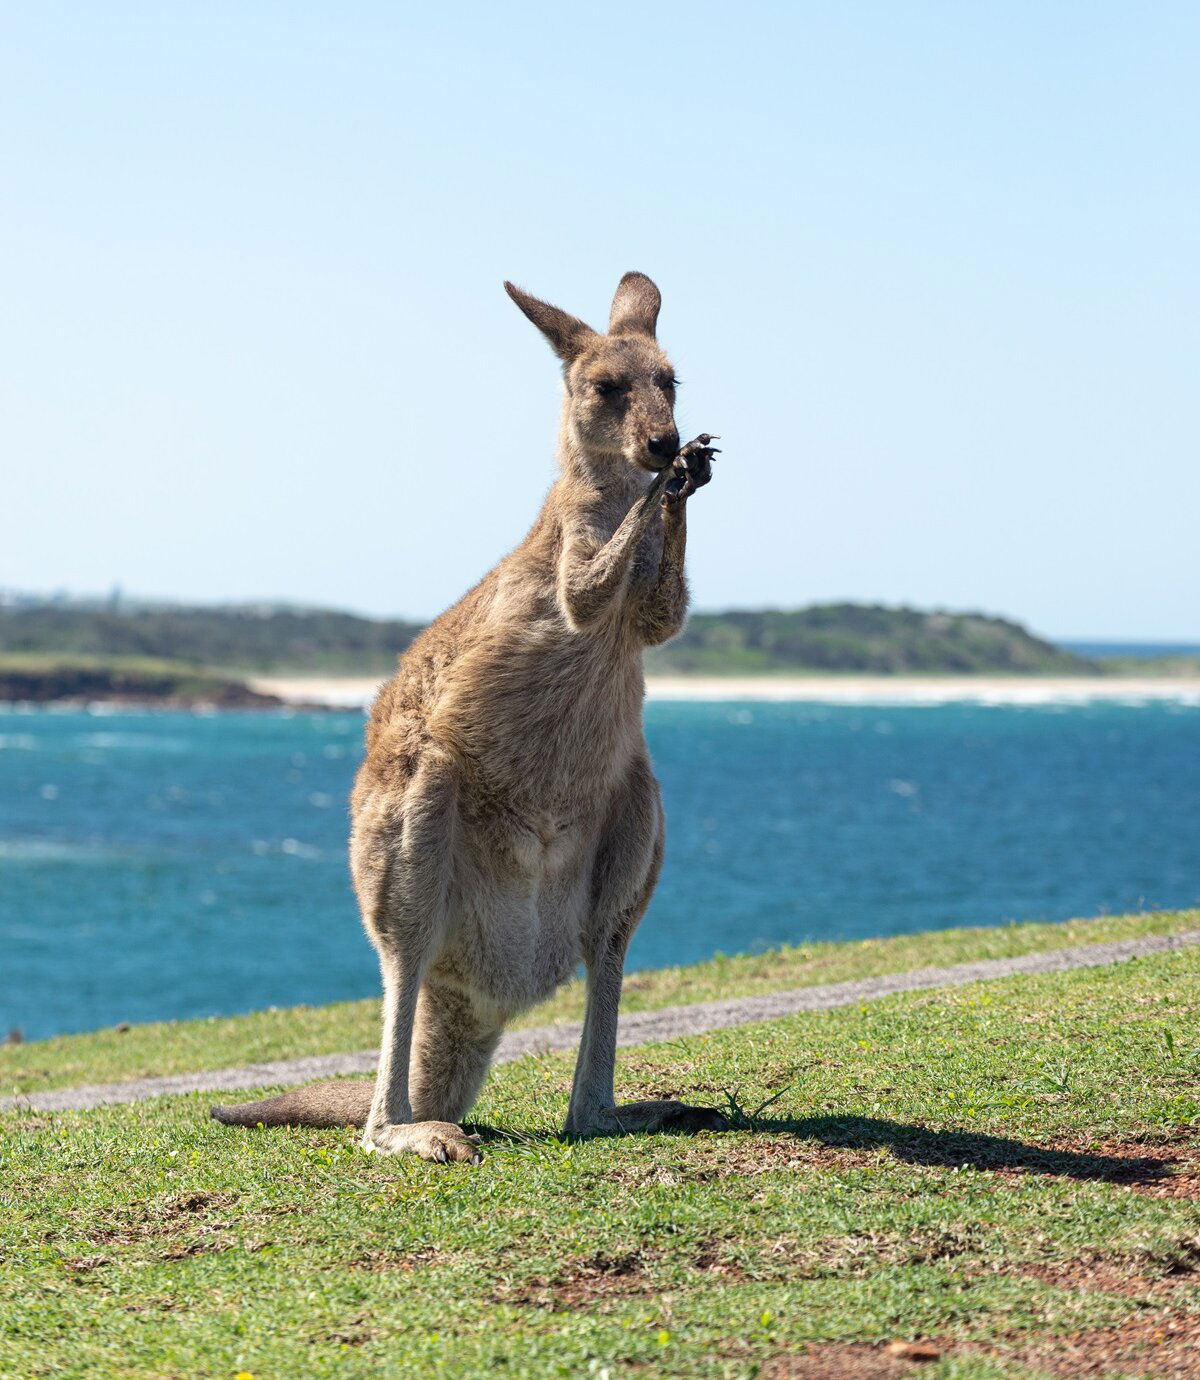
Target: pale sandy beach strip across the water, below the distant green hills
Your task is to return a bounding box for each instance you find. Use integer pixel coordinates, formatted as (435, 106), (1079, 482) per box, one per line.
(250, 675), (1200, 709)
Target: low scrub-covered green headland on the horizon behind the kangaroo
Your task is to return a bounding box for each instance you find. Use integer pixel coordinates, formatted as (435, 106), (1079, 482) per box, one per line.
(0, 595), (1200, 708)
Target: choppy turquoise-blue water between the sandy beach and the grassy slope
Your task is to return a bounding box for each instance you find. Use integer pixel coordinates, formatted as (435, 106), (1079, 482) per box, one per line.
(0, 701), (1200, 1038)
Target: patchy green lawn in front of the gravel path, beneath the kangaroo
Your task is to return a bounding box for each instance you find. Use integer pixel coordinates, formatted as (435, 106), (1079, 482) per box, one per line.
(0, 916), (1200, 1380)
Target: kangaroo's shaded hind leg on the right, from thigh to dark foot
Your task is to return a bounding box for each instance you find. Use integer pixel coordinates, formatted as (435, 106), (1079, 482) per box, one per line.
(564, 758), (728, 1136)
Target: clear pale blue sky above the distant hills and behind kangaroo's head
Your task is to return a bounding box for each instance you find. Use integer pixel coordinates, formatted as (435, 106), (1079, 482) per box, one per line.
(0, 0), (1200, 640)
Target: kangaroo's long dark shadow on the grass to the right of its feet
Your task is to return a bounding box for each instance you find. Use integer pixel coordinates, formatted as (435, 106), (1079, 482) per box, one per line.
(754, 1115), (1171, 1184)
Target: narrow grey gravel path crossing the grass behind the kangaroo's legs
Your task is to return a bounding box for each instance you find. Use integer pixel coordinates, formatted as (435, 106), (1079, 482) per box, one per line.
(0, 930), (1200, 1111)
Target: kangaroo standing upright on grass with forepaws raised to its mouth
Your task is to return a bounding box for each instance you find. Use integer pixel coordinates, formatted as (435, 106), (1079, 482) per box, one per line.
(212, 273), (726, 1163)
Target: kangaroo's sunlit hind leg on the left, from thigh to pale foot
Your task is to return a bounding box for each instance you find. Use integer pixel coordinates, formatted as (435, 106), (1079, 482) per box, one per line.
(350, 751), (480, 1163)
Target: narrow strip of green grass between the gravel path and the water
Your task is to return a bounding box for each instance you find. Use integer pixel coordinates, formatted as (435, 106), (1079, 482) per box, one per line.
(0, 911), (1200, 1096)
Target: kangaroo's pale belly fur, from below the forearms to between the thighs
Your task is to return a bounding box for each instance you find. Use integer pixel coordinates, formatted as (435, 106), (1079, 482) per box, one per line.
(386, 596), (646, 1016)
